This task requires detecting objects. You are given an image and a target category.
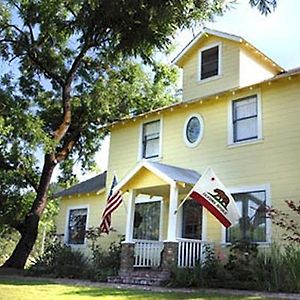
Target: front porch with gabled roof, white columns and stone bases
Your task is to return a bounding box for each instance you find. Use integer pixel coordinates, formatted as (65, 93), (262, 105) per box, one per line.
(112, 162), (206, 283)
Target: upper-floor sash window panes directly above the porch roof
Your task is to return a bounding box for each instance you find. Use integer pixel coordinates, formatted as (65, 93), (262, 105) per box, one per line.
(142, 120), (160, 158)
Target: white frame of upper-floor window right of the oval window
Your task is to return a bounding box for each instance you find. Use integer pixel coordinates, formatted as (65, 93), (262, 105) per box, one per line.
(227, 91), (263, 146)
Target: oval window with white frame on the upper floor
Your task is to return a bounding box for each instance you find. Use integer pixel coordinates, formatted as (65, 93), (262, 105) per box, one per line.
(184, 114), (203, 147)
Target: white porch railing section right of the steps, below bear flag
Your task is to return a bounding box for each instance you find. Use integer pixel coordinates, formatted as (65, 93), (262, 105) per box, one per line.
(177, 238), (203, 268)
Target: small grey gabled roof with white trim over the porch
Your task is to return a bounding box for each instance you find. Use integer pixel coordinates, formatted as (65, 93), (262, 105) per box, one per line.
(115, 160), (200, 190)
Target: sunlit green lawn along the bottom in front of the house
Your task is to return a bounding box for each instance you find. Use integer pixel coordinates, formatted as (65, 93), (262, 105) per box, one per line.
(0, 278), (282, 300)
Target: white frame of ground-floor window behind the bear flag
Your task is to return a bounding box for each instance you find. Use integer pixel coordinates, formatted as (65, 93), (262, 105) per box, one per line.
(221, 184), (272, 246)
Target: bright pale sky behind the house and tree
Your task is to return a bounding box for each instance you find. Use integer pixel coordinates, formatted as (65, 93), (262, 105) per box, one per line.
(73, 0), (300, 180)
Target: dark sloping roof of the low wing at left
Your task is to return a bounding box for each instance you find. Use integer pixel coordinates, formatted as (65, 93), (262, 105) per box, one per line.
(53, 171), (107, 198)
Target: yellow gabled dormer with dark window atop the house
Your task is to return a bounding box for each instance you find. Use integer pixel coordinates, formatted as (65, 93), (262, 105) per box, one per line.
(174, 28), (284, 101)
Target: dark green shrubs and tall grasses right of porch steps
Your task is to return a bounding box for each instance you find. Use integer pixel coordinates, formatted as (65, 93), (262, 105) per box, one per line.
(169, 241), (300, 292)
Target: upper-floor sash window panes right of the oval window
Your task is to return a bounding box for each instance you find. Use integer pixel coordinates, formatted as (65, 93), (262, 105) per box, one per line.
(232, 95), (259, 143)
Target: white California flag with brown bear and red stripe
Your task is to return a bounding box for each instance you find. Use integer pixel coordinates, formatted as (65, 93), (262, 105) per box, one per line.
(189, 168), (241, 227)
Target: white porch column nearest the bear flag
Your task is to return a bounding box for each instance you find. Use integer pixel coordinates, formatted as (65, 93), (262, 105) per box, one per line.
(167, 182), (178, 242)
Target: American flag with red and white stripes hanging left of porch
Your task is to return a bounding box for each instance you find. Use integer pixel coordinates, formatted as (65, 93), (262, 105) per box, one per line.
(100, 175), (123, 234)
